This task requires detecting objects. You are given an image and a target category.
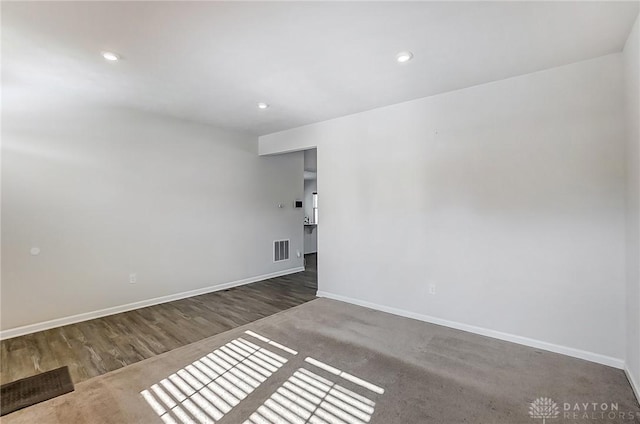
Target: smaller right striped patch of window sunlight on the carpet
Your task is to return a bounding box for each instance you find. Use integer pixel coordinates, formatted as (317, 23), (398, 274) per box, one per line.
(244, 358), (384, 424)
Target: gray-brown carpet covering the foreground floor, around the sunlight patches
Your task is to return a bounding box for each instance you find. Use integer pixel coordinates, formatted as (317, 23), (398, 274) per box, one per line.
(1, 299), (640, 424)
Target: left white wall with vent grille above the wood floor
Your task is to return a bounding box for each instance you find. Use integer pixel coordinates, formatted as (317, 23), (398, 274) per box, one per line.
(1, 102), (303, 330)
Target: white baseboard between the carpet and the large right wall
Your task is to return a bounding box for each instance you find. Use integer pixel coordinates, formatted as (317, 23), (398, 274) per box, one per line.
(317, 291), (625, 369)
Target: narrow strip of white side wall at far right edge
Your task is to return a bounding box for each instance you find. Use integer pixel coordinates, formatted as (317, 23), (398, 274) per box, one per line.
(623, 14), (640, 399)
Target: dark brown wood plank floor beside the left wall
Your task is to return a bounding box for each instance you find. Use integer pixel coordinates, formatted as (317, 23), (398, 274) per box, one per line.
(0, 254), (317, 384)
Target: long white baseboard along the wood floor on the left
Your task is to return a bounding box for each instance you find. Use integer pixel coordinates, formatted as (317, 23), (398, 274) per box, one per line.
(0, 267), (304, 340)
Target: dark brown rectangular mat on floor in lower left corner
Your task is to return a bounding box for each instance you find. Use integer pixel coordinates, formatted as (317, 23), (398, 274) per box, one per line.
(0, 367), (73, 416)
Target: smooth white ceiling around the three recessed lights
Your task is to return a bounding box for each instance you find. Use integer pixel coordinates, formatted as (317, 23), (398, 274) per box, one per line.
(2, 1), (638, 135)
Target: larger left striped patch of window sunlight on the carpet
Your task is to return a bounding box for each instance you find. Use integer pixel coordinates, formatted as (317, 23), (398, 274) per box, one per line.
(140, 333), (297, 424)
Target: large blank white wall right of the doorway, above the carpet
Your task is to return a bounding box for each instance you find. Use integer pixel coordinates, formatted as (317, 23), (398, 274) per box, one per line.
(259, 54), (625, 366)
